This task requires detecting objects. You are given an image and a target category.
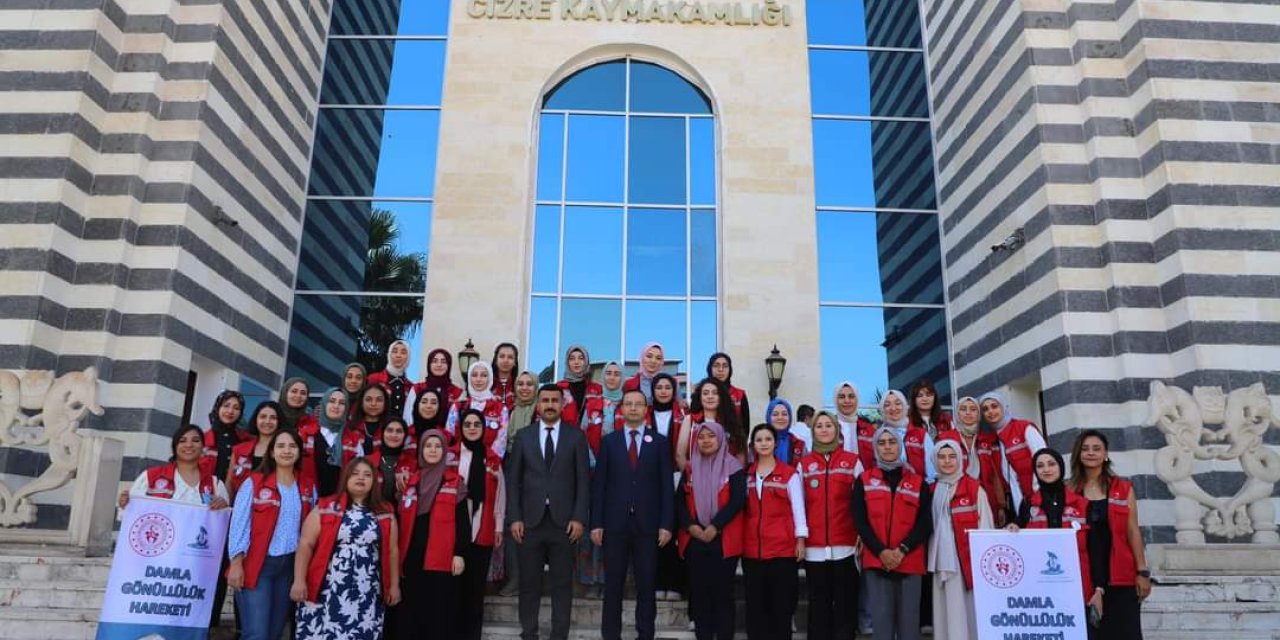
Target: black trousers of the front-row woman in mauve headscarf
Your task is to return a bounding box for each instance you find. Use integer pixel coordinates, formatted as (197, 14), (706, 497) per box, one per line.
(685, 538), (737, 640)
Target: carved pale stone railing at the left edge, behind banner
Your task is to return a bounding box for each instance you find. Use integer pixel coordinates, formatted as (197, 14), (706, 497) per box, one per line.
(0, 367), (124, 554)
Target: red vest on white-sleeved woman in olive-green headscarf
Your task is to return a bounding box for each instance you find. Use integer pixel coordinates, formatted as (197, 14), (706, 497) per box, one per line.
(799, 448), (860, 547)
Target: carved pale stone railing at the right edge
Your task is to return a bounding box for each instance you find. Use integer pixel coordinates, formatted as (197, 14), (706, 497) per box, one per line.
(1147, 380), (1280, 545)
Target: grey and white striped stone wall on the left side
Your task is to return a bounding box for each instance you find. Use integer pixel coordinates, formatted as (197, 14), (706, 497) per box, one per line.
(0, 0), (332, 525)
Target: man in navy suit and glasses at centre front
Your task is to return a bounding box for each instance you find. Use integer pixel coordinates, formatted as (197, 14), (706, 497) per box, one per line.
(591, 389), (676, 640)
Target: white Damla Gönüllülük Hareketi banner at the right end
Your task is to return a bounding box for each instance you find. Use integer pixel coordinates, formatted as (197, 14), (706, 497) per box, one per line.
(969, 529), (1088, 640)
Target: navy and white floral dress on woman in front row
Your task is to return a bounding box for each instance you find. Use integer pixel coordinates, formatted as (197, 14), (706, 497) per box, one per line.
(297, 506), (383, 640)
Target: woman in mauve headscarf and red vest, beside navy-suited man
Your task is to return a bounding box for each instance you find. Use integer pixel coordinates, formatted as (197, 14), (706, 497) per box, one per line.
(676, 422), (746, 640)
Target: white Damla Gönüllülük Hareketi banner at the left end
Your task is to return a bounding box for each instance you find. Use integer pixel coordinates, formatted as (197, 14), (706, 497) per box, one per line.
(97, 498), (230, 640)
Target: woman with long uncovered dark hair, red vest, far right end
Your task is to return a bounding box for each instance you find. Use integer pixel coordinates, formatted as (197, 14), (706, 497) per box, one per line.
(1070, 429), (1151, 640)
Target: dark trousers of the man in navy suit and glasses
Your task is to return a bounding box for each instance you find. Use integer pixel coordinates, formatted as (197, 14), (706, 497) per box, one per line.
(600, 515), (658, 640)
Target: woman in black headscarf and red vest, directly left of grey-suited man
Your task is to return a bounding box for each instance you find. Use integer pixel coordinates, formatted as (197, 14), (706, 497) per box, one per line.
(456, 408), (507, 640)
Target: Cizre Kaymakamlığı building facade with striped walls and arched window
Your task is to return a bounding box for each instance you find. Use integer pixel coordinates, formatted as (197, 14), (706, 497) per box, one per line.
(0, 0), (1280, 560)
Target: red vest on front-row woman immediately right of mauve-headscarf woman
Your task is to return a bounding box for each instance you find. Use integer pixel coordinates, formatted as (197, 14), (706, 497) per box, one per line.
(742, 462), (796, 559)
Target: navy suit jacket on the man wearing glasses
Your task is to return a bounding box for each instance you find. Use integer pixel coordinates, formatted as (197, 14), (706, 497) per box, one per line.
(591, 426), (676, 540)
